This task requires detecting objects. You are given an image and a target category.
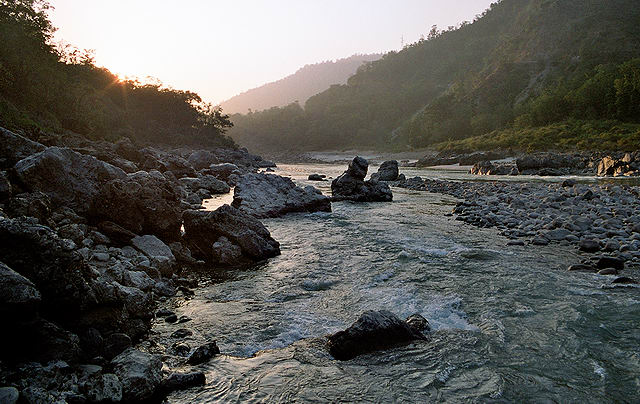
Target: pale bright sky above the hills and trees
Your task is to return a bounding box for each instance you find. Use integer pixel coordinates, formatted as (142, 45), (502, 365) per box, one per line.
(50, 0), (495, 104)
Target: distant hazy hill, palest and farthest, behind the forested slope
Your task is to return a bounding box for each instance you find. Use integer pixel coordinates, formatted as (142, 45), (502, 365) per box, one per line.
(221, 54), (382, 113)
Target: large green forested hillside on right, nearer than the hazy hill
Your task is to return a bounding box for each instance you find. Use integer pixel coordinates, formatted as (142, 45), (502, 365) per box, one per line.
(231, 0), (640, 153)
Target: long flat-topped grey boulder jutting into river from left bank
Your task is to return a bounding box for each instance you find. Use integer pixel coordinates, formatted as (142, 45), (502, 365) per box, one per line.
(232, 174), (331, 218)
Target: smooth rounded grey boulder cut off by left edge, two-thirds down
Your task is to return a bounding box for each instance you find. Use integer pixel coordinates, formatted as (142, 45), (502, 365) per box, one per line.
(0, 262), (42, 322)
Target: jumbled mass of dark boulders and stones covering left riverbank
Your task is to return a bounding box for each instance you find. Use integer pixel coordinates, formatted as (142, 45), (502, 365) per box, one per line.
(0, 128), (279, 402)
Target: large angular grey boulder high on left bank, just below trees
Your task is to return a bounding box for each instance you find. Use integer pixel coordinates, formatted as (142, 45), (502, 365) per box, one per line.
(15, 147), (126, 215)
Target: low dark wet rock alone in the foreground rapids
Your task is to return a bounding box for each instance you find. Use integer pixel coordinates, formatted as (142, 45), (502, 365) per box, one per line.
(327, 311), (425, 360)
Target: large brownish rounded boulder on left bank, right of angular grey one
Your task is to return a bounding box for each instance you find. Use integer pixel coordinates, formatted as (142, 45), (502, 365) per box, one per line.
(90, 170), (182, 241)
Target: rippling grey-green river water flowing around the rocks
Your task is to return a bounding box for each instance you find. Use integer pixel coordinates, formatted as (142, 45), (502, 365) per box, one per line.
(161, 165), (640, 403)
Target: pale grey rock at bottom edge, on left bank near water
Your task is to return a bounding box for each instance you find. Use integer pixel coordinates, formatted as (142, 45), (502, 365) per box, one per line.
(111, 348), (162, 402)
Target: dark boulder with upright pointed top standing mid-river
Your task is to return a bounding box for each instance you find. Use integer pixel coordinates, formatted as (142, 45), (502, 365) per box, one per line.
(331, 157), (393, 202)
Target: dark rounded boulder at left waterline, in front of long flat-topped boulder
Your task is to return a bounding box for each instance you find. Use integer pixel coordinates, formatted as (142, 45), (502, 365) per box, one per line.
(183, 205), (280, 265)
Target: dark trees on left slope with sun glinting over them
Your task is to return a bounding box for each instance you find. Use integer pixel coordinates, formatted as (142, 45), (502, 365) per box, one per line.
(0, 0), (233, 146)
